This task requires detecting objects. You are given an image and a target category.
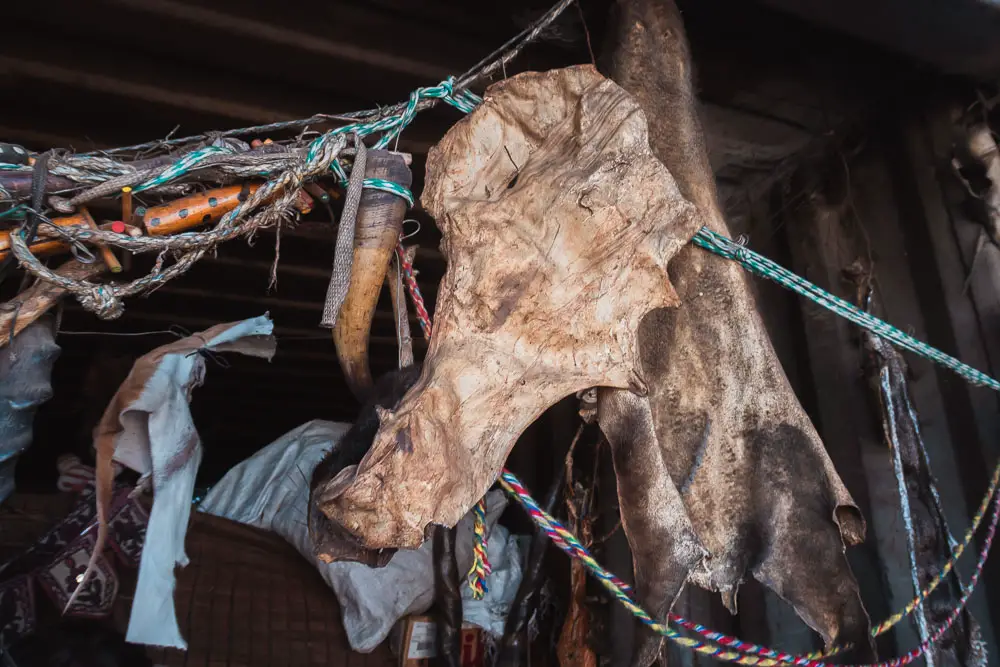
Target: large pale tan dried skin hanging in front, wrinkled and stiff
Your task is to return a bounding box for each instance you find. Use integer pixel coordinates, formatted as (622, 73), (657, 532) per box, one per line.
(321, 66), (699, 548)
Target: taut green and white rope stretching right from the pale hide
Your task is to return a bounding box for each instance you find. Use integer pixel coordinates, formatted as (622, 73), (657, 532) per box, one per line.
(691, 227), (1000, 391)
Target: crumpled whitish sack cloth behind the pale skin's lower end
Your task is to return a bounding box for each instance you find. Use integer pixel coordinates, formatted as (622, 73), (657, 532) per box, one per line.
(198, 420), (521, 653)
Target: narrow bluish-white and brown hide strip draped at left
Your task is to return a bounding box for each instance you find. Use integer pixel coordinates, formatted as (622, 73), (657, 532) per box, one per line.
(74, 315), (276, 649)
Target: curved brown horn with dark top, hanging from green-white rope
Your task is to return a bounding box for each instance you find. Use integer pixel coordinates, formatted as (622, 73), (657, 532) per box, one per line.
(333, 150), (413, 401)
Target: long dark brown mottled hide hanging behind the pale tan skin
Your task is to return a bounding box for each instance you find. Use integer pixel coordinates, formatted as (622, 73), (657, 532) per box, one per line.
(598, 0), (873, 665)
